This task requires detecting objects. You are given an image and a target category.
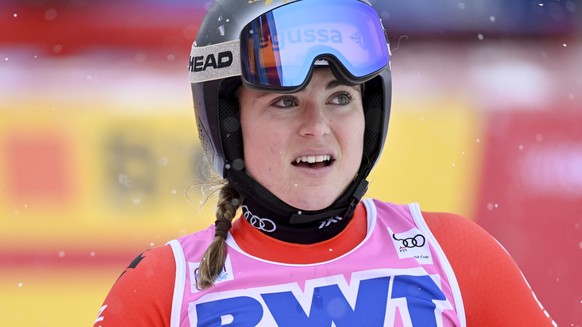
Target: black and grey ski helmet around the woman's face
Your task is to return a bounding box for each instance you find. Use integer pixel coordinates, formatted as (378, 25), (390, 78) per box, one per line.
(189, 0), (391, 223)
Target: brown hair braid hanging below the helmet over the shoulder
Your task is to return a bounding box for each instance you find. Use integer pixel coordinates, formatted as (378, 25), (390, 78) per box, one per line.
(196, 182), (242, 290)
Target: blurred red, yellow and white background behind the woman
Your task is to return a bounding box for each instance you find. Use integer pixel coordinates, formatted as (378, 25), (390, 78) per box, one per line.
(0, 0), (582, 326)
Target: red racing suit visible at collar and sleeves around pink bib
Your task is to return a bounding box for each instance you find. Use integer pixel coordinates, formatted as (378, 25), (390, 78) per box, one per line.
(94, 204), (555, 327)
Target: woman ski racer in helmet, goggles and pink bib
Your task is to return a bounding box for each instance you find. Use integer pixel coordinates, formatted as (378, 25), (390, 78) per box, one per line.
(95, 0), (552, 326)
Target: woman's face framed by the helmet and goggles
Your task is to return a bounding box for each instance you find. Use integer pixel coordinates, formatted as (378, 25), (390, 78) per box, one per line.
(239, 69), (364, 210)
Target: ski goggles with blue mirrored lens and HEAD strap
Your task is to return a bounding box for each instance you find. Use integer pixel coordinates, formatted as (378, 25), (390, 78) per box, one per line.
(189, 0), (390, 92)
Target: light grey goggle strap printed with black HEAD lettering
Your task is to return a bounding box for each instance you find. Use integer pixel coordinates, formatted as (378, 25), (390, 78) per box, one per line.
(188, 40), (241, 83)
